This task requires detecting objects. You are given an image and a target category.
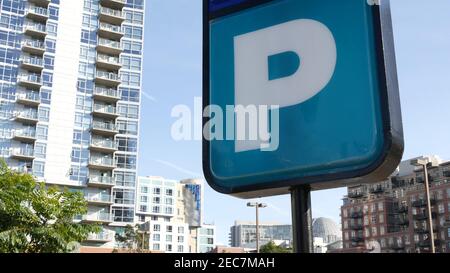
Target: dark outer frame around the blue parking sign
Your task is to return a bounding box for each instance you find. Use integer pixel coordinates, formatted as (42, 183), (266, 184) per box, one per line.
(202, 0), (404, 199)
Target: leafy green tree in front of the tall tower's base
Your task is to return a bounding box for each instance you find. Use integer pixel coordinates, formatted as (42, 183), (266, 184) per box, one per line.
(0, 161), (100, 253)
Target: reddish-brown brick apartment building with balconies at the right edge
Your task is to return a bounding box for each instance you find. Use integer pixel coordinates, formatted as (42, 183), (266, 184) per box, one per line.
(341, 156), (450, 253)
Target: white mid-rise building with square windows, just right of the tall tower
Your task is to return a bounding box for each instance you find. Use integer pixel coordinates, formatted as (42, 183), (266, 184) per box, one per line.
(136, 177), (216, 253)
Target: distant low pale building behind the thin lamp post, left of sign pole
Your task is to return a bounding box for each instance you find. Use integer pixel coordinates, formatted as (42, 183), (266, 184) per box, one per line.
(230, 221), (292, 248)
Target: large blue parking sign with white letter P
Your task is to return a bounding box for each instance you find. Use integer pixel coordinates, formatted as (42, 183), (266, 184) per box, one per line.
(203, 0), (403, 198)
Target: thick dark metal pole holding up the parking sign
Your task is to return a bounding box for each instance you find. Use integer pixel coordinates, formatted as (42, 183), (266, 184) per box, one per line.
(291, 185), (314, 253)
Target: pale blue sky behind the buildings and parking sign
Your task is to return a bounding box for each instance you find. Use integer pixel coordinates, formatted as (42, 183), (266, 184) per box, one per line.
(139, 0), (450, 244)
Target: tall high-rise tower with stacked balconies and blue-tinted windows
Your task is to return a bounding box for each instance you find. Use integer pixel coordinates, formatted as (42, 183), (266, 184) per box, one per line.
(0, 0), (145, 246)
